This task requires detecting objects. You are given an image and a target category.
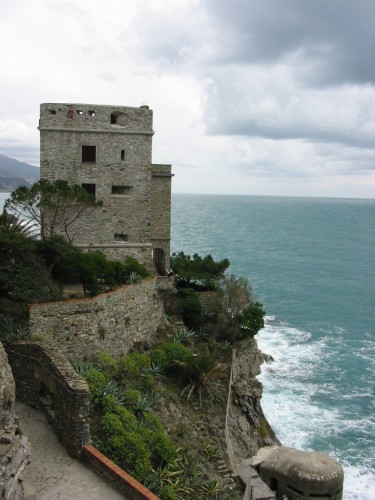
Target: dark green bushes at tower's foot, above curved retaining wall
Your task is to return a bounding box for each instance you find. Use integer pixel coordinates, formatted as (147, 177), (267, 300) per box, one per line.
(0, 203), (149, 327)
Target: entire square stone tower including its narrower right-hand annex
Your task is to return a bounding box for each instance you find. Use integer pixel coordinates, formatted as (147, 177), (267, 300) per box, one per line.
(39, 103), (172, 275)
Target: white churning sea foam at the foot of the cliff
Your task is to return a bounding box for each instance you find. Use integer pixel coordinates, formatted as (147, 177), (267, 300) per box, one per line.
(258, 317), (375, 500)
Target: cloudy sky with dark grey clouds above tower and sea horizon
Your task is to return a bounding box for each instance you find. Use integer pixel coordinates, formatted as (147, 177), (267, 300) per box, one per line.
(0, 0), (375, 198)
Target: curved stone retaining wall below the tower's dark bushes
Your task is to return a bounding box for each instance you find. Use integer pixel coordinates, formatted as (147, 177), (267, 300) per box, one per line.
(30, 278), (169, 359)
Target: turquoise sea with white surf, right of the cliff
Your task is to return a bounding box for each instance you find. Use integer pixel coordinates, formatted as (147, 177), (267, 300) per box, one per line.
(172, 194), (375, 500)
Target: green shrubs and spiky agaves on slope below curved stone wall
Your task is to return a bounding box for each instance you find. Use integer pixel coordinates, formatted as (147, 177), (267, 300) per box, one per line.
(72, 338), (236, 500)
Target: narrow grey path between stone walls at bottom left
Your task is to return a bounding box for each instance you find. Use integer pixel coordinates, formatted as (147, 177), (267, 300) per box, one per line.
(15, 402), (124, 500)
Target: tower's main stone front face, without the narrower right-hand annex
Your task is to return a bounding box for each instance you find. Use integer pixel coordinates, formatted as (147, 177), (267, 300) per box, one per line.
(39, 104), (153, 248)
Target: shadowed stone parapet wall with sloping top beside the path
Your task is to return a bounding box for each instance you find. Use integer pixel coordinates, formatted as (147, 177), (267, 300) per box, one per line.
(7, 342), (90, 457)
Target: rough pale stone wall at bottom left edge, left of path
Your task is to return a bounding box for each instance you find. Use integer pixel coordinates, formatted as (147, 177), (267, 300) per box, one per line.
(0, 342), (30, 500)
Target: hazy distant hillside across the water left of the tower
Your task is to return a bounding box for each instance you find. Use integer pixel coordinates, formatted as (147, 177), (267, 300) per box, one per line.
(0, 155), (39, 193)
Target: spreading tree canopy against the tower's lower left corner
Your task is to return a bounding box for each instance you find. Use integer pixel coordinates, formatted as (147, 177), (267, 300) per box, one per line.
(4, 179), (102, 241)
